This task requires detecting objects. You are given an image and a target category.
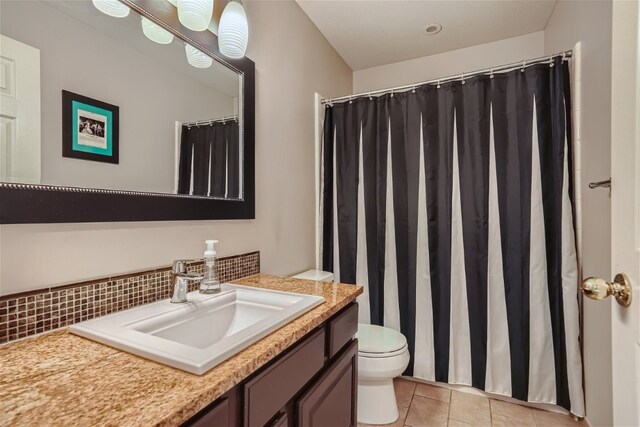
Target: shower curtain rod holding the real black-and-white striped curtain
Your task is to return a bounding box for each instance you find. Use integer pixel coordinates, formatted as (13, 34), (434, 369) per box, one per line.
(320, 50), (573, 105)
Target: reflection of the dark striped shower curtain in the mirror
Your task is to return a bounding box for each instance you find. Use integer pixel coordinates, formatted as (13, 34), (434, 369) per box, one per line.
(178, 120), (240, 199)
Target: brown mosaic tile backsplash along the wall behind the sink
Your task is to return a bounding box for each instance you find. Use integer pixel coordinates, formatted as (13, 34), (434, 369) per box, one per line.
(0, 252), (260, 344)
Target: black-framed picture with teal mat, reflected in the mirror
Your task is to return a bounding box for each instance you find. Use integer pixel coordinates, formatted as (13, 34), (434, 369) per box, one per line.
(62, 90), (119, 164)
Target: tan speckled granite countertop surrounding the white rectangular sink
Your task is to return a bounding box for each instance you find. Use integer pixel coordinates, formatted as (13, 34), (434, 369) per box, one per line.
(0, 274), (362, 426)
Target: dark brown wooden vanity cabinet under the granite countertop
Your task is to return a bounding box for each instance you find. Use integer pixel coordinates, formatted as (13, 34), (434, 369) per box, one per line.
(186, 303), (358, 427)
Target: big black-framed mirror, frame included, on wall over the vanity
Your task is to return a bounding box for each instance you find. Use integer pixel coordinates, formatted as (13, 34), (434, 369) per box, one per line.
(0, 0), (255, 224)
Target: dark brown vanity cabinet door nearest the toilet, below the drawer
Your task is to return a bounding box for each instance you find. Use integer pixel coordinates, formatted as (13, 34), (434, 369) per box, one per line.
(296, 340), (358, 427)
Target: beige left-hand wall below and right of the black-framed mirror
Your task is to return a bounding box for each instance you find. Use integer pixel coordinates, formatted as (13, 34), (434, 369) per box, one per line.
(0, 1), (352, 294)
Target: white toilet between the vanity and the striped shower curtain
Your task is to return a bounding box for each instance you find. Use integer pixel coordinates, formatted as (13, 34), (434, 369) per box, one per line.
(293, 270), (409, 424)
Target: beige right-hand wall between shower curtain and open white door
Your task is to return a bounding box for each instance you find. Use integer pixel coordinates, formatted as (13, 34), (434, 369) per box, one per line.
(544, 1), (613, 426)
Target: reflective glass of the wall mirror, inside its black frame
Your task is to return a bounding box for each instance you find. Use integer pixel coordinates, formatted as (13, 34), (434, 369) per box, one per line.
(0, 0), (242, 201)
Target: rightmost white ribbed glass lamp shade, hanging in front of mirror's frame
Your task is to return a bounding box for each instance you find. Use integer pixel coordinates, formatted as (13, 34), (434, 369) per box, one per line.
(218, 0), (249, 58)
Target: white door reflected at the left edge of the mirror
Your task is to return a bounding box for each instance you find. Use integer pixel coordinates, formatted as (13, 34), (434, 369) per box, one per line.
(0, 34), (40, 184)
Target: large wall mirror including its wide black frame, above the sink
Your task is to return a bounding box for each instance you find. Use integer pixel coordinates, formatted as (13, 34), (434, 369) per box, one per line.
(0, 0), (255, 224)
